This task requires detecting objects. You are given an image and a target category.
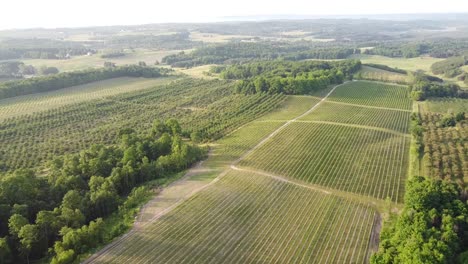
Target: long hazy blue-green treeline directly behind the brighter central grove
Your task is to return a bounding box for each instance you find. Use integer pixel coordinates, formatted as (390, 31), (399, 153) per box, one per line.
(162, 41), (360, 68)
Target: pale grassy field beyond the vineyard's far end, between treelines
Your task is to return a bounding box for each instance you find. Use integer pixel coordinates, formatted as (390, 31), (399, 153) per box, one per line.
(352, 54), (443, 73)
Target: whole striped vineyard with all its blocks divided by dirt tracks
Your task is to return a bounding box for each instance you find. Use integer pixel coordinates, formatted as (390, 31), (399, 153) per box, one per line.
(81, 79), (410, 263)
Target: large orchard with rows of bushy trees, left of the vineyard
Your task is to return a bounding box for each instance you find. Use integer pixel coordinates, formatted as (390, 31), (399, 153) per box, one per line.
(0, 79), (286, 171)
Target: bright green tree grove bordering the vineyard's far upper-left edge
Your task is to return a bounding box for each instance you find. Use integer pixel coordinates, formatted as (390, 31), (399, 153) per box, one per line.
(220, 60), (361, 94)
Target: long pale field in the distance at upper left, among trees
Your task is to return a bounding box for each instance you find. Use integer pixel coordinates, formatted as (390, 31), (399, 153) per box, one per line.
(19, 49), (185, 72)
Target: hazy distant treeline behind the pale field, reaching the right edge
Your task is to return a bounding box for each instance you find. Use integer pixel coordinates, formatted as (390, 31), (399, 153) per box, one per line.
(364, 39), (468, 58)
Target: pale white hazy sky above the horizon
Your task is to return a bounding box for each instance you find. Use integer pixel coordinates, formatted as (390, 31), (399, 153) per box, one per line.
(0, 0), (468, 29)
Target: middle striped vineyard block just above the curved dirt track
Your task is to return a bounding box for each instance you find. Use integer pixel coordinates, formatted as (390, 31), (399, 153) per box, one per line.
(240, 122), (409, 201)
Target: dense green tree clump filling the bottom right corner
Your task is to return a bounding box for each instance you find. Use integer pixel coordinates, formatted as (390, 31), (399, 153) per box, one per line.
(371, 176), (468, 264)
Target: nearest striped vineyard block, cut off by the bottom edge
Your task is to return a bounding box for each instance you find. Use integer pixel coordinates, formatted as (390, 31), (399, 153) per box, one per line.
(88, 171), (375, 263)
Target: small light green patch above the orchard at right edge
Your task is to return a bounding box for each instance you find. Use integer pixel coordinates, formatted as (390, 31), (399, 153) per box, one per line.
(418, 98), (468, 114)
